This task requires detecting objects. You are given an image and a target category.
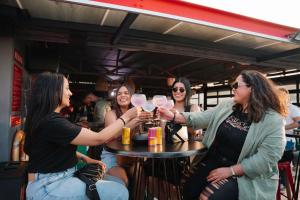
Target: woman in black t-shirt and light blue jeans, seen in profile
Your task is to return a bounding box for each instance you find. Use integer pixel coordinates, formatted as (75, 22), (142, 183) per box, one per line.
(25, 73), (137, 200)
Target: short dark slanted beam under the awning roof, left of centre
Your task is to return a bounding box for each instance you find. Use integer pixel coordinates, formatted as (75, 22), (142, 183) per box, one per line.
(111, 13), (138, 45)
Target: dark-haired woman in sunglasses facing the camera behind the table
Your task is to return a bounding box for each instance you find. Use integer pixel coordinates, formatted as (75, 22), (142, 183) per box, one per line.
(172, 77), (201, 139)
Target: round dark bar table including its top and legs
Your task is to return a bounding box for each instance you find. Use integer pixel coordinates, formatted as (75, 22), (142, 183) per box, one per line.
(105, 140), (207, 199)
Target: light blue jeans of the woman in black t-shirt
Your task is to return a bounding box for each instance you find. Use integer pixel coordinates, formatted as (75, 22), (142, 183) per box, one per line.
(26, 167), (129, 200)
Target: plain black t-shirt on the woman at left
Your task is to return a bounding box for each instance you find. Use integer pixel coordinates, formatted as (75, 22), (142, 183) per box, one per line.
(28, 112), (81, 173)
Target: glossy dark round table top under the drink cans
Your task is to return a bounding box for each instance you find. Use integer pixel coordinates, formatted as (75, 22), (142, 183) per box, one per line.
(105, 140), (207, 158)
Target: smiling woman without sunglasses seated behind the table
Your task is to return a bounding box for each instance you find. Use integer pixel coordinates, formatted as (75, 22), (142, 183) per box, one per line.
(101, 84), (151, 185)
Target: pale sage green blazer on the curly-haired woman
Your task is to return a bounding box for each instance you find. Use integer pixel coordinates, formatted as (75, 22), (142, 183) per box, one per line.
(182, 99), (286, 200)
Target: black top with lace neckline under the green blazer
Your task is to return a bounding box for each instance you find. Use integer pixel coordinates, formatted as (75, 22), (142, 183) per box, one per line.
(214, 111), (251, 163)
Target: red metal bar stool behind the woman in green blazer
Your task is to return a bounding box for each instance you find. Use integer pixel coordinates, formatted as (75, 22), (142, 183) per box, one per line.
(276, 161), (295, 200)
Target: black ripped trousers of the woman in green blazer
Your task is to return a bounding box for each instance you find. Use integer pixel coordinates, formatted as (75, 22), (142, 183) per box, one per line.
(183, 152), (238, 200)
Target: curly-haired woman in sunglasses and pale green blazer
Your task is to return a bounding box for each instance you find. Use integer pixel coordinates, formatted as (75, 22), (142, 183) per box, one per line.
(159, 70), (287, 200)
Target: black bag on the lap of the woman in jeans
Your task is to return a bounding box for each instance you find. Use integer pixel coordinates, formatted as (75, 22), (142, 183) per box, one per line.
(74, 163), (104, 200)
